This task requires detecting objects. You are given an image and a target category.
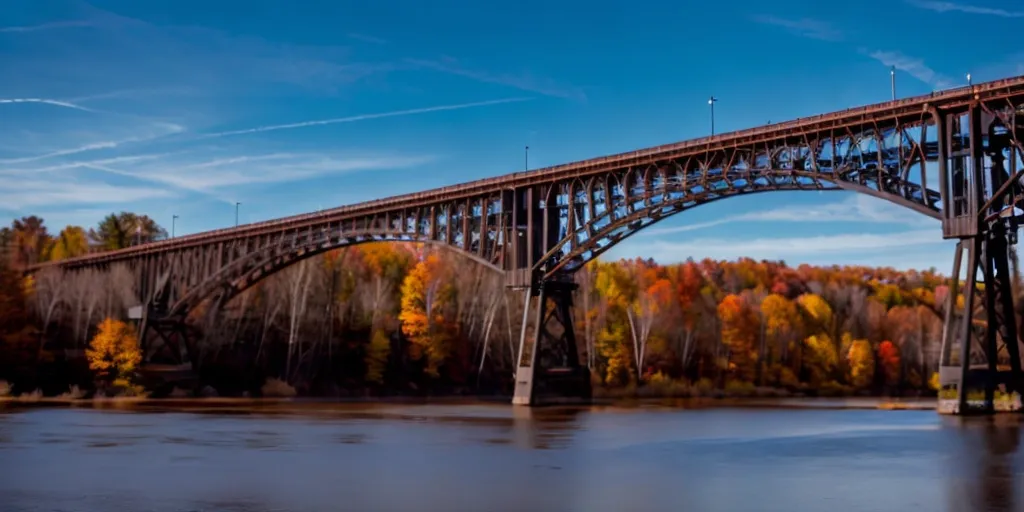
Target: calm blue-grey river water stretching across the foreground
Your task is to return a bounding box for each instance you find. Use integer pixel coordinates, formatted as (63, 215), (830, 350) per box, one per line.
(0, 404), (1024, 512)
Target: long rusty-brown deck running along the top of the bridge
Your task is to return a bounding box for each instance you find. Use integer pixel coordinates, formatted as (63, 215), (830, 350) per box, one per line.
(34, 76), (1024, 268)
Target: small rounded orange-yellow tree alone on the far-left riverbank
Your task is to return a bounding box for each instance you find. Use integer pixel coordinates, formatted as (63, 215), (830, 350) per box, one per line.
(85, 318), (142, 382)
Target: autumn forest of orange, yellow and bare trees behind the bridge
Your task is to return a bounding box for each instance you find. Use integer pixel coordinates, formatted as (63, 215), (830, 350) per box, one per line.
(0, 212), (949, 397)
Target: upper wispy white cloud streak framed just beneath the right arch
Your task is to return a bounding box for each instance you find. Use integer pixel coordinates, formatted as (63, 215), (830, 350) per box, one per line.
(638, 195), (936, 236)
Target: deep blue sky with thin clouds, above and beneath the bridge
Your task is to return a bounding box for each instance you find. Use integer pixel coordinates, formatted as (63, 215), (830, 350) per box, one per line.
(0, 0), (1024, 272)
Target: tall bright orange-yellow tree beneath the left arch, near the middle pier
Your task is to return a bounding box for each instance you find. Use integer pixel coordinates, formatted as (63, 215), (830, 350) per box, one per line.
(398, 254), (453, 377)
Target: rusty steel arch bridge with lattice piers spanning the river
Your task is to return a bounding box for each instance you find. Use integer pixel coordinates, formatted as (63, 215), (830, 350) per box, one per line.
(29, 77), (1024, 414)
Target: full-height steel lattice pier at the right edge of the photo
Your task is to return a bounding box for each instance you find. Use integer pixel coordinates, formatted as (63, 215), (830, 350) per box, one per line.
(933, 102), (1024, 415)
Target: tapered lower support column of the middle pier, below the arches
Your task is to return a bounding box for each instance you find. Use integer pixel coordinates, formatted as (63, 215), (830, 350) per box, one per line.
(512, 281), (591, 406)
